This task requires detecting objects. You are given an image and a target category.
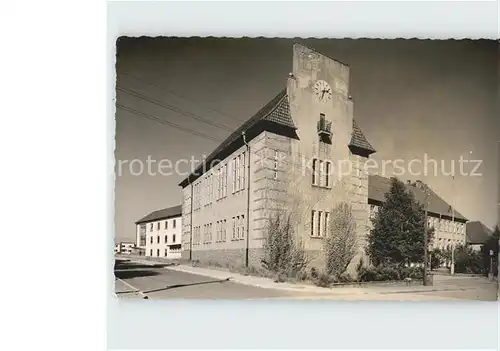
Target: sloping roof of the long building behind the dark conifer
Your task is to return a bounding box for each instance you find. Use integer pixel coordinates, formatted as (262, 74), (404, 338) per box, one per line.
(368, 175), (467, 222)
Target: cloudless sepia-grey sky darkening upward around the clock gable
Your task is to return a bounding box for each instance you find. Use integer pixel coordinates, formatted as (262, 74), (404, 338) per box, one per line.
(115, 37), (500, 241)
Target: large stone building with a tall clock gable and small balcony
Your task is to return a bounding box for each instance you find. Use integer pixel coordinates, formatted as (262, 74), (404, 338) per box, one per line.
(179, 44), (375, 271)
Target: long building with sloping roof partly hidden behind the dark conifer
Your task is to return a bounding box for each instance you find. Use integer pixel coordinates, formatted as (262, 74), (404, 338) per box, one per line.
(368, 175), (467, 250)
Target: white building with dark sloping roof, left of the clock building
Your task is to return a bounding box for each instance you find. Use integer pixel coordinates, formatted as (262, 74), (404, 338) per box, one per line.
(135, 206), (182, 259)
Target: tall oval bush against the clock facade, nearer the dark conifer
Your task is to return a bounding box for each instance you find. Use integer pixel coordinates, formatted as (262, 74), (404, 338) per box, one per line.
(324, 202), (357, 280)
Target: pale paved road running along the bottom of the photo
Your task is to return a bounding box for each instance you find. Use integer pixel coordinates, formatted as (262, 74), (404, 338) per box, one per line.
(115, 261), (497, 301)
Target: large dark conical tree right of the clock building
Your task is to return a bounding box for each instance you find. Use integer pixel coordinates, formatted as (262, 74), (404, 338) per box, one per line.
(367, 178), (434, 265)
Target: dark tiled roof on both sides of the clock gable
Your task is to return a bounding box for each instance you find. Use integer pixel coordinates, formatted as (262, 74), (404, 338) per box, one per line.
(179, 89), (375, 188)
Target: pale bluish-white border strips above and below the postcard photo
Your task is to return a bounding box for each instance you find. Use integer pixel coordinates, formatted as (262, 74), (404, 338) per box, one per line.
(108, 1), (498, 349)
